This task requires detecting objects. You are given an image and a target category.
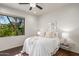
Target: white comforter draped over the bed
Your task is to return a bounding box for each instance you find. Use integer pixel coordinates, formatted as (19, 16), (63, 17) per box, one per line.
(22, 36), (59, 56)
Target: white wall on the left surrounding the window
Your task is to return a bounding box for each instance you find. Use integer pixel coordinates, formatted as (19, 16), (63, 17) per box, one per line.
(0, 7), (37, 51)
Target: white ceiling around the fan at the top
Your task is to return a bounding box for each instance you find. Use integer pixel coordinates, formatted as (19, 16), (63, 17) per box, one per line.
(0, 3), (68, 15)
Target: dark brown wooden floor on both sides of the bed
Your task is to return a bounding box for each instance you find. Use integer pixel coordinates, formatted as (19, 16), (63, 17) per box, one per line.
(0, 46), (79, 56)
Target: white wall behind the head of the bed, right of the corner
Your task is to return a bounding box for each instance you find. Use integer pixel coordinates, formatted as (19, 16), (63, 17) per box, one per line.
(39, 4), (79, 53)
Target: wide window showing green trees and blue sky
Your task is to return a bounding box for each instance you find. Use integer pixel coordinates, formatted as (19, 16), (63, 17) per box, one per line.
(0, 15), (25, 37)
